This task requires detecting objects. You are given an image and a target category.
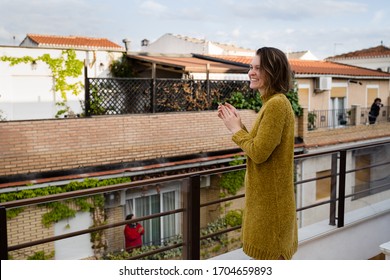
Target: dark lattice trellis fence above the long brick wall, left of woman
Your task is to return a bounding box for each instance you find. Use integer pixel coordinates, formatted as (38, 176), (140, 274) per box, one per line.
(85, 78), (253, 116)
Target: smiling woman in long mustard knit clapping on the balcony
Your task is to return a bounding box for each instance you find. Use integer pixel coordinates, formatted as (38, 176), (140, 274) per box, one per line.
(218, 47), (298, 259)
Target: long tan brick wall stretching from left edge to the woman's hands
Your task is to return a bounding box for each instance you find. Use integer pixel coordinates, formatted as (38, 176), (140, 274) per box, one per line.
(0, 110), (256, 176)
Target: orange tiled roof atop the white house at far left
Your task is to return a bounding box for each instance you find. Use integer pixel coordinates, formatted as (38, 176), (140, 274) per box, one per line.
(25, 34), (124, 51)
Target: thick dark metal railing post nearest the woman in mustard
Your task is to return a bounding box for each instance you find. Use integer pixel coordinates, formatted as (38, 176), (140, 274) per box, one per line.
(183, 174), (200, 260)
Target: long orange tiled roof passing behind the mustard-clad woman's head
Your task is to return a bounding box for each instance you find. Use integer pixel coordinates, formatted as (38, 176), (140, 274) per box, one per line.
(197, 55), (390, 77)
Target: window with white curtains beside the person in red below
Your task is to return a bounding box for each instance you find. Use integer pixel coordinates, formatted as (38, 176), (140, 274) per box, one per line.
(126, 186), (180, 245)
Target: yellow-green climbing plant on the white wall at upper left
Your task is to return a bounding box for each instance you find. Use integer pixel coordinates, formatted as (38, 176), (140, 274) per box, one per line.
(0, 50), (84, 118)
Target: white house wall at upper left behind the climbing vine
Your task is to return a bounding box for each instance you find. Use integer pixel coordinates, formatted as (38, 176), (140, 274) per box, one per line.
(0, 46), (122, 120)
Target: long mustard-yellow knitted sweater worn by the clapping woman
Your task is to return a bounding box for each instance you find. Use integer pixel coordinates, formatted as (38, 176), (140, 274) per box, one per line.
(232, 94), (298, 259)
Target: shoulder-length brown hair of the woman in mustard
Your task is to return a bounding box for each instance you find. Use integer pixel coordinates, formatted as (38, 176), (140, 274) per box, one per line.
(256, 47), (293, 97)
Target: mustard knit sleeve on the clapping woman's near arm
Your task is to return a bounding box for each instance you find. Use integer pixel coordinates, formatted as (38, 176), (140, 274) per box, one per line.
(232, 98), (289, 164)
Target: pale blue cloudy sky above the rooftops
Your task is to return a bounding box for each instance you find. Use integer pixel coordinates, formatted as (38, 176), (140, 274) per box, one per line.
(0, 0), (390, 59)
